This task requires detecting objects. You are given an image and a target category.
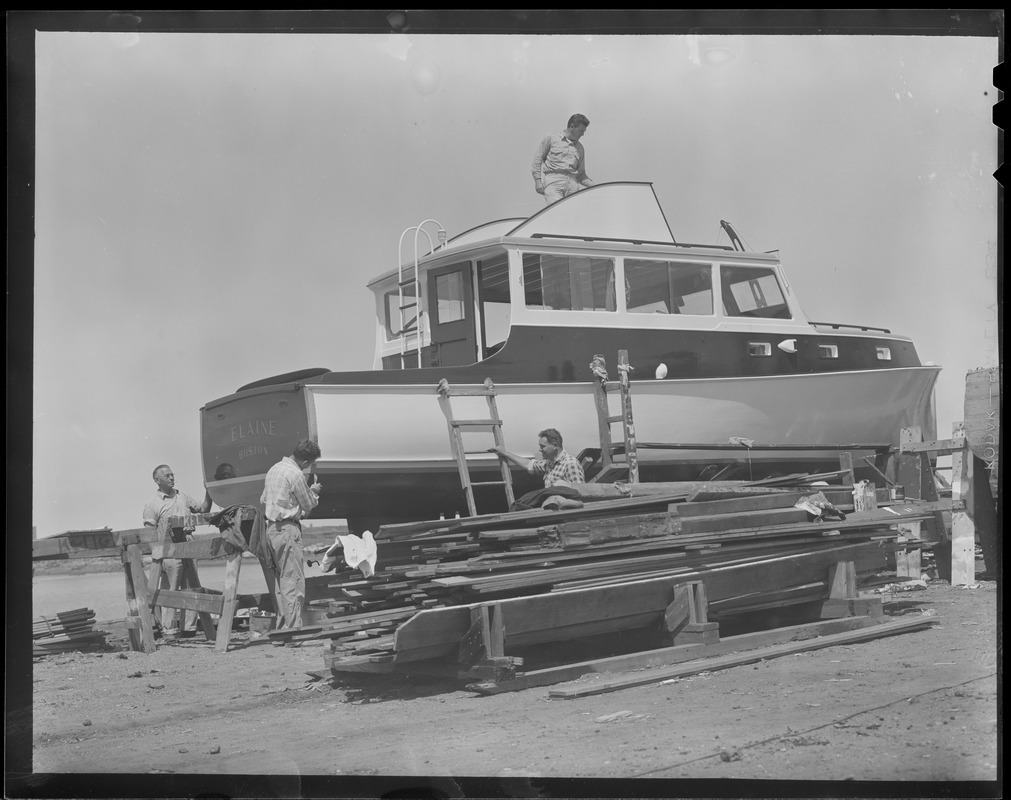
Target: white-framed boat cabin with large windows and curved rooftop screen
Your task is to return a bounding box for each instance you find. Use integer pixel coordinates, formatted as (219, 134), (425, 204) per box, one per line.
(369, 183), (811, 370)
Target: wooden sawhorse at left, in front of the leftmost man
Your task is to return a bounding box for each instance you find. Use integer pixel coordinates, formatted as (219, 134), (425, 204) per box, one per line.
(119, 514), (254, 652)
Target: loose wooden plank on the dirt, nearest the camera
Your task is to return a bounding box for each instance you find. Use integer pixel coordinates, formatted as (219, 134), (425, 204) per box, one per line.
(548, 617), (938, 699)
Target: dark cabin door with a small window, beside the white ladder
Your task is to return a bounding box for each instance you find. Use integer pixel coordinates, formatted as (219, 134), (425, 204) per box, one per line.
(422, 261), (477, 367)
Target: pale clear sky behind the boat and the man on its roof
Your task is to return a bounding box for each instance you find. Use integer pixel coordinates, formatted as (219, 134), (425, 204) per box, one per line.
(25, 12), (999, 537)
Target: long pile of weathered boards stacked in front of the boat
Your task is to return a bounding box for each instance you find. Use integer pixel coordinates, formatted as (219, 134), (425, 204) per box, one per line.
(270, 485), (929, 670)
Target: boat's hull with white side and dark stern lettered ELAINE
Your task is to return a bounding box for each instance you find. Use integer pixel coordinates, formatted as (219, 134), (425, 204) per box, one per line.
(203, 366), (939, 530)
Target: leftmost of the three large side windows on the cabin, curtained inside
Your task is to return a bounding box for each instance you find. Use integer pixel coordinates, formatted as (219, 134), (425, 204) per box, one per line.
(523, 253), (618, 312)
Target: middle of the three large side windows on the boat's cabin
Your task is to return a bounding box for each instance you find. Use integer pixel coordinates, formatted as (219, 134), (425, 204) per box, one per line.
(625, 258), (713, 315)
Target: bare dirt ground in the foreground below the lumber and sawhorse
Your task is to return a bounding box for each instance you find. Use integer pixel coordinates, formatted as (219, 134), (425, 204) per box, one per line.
(19, 562), (1001, 797)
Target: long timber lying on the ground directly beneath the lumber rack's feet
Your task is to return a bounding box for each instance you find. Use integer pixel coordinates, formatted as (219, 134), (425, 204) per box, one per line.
(467, 617), (879, 695)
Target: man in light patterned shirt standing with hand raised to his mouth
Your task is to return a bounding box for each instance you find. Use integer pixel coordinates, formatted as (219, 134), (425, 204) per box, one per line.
(260, 439), (323, 628)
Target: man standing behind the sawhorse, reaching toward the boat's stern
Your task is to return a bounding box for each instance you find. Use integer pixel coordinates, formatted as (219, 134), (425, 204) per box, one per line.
(144, 464), (210, 636)
